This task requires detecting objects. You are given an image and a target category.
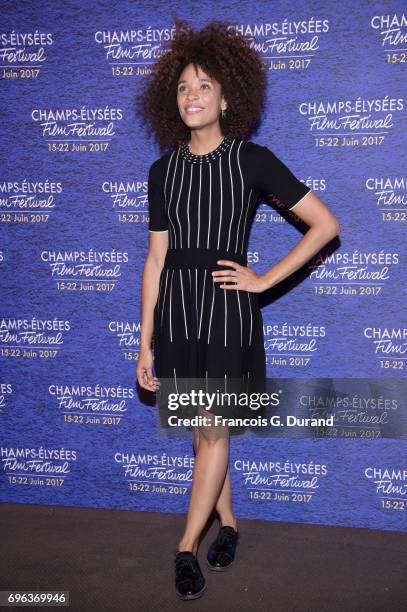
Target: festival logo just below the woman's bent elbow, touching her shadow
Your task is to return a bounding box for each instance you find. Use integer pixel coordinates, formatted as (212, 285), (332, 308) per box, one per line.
(308, 250), (400, 297)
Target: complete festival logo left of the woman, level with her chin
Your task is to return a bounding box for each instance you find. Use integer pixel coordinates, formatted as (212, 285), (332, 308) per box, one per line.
(31, 106), (123, 154)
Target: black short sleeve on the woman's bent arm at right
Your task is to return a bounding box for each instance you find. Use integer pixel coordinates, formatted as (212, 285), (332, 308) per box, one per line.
(250, 143), (311, 210)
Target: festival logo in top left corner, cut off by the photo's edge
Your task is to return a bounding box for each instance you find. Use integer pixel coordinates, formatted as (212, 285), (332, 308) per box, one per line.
(0, 30), (54, 80)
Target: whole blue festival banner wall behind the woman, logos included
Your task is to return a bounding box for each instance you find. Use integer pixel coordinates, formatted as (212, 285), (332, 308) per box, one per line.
(0, 0), (407, 531)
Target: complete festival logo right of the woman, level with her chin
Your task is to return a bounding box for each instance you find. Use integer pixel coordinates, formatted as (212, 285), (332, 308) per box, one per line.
(298, 96), (405, 148)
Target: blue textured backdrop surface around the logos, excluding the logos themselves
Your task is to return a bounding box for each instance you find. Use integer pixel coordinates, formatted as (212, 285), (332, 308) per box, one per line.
(0, 0), (407, 531)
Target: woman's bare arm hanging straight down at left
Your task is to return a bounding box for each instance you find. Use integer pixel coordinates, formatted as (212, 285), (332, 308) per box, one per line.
(136, 231), (168, 391)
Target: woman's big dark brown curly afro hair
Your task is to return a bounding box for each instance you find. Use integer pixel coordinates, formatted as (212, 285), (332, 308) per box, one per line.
(136, 19), (267, 150)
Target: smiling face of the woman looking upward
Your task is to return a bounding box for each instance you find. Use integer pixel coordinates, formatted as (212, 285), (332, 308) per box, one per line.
(177, 64), (226, 129)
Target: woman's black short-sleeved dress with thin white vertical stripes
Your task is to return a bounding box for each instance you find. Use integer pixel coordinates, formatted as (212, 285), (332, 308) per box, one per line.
(148, 137), (310, 432)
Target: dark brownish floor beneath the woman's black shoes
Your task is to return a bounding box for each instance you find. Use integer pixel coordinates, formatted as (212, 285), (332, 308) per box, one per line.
(0, 504), (407, 612)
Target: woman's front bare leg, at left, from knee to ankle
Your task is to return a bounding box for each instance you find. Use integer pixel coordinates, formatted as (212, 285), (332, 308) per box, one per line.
(178, 414), (233, 555)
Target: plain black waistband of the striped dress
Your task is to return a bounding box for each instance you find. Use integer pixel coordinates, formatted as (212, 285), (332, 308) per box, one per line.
(164, 248), (247, 270)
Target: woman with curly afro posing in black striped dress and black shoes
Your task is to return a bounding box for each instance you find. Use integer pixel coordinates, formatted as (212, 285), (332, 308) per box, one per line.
(136, 20), (339, 599)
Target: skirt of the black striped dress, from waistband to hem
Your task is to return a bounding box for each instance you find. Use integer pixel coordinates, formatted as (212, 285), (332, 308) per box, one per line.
(153, 249), (266, 433)
